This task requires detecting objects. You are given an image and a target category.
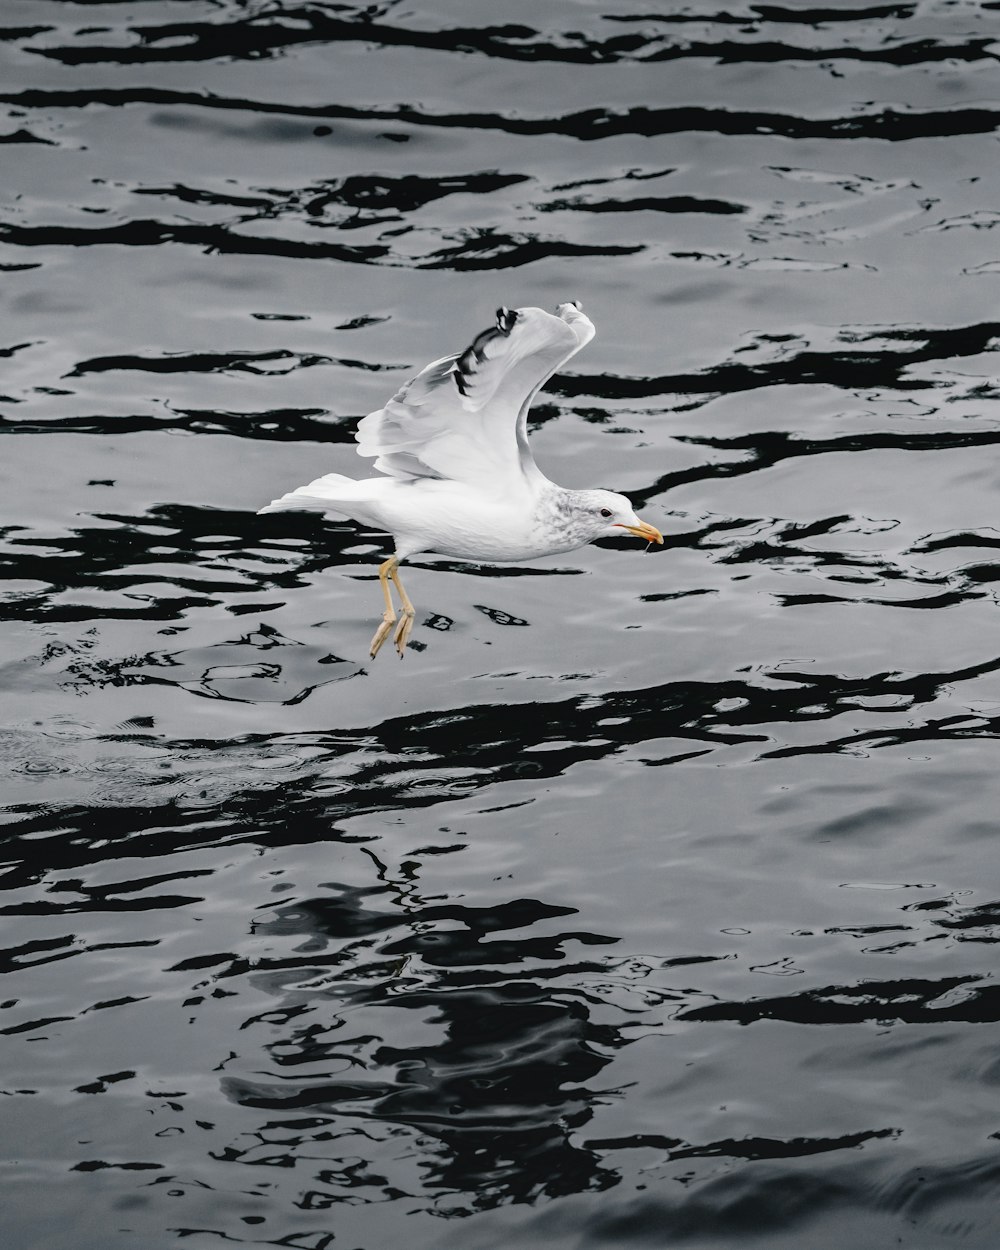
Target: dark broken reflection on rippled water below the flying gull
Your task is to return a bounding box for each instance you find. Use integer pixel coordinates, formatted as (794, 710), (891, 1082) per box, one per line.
(216, 880), (620, 1214)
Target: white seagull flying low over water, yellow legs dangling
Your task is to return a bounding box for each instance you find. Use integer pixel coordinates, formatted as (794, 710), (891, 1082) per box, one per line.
(260, 300), (664, 660)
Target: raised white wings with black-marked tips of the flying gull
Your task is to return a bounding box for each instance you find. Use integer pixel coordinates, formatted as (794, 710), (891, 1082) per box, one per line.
(356, 304), (594, 491)
